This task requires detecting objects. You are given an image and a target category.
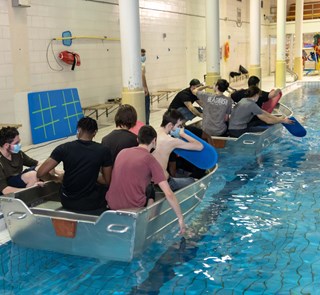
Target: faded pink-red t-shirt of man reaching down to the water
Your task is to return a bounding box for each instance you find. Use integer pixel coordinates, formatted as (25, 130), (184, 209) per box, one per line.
(106, 146), (166, 210)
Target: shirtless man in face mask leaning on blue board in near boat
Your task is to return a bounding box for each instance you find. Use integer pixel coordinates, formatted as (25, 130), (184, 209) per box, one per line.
(153, 109), (203, 191)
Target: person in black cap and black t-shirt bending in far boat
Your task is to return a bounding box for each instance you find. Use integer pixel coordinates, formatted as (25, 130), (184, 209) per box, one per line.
(169, 79), (202, 121)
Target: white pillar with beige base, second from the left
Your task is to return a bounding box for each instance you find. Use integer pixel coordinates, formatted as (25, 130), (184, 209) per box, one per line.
(206, 0), (220, 91)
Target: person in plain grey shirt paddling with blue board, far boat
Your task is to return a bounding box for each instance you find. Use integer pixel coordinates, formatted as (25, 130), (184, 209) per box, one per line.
(229, 86), (293, 137)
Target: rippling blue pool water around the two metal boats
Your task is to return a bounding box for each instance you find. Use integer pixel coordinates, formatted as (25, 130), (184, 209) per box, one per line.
(0, 84), (320, 295)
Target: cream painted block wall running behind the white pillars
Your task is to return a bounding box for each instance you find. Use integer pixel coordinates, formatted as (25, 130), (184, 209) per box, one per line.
(0, 0), (276, 143)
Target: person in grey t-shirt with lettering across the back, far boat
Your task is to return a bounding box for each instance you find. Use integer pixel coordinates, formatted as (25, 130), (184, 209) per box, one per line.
(192, 79), (232, 139)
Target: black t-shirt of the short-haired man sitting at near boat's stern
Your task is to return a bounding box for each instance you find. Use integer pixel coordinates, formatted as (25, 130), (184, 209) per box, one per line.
(50, 140), (112, 199)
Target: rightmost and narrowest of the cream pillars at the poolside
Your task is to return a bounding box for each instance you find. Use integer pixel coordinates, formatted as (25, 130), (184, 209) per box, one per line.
(294, 0), (304, 80)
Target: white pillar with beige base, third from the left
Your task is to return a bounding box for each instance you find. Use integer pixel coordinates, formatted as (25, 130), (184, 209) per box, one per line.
(249, 0), (261, 87)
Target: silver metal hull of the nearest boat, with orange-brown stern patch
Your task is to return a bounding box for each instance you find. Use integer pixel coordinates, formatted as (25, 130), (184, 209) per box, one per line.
(0, 170), (215, 261)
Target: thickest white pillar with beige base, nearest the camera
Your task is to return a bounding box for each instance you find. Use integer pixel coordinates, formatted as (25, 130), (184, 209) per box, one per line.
(119, 0), (145, 122)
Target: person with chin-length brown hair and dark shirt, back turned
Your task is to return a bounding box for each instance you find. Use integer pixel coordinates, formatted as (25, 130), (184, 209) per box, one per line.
(101, 104), (138, 164)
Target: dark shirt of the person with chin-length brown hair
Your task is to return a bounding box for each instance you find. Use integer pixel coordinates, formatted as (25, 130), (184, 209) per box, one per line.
(101, 129), (138, 164)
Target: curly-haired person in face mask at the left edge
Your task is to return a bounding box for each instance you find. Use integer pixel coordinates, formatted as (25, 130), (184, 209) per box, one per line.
(0, 127), (43, 195)
